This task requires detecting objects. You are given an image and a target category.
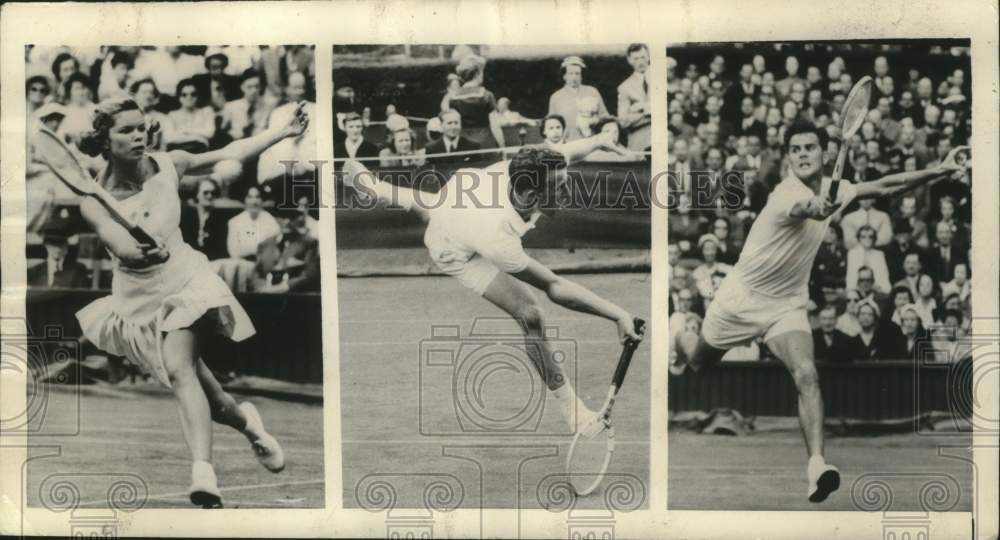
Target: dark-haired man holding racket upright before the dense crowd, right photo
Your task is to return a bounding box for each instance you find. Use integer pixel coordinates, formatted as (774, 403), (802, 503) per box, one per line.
(675, 122), (962, 502)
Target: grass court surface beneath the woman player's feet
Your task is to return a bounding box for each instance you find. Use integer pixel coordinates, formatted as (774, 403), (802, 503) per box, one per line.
(26, 385), (325, 508)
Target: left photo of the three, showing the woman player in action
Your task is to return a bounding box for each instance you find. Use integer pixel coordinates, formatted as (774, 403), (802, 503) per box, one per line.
(24, 45), (325, 511)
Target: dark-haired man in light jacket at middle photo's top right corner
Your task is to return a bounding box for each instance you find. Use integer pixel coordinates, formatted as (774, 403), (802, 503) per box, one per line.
(618, 43), (652, 151)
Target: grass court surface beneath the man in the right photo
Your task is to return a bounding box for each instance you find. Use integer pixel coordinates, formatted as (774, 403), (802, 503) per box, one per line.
(667, 430), (973, 512)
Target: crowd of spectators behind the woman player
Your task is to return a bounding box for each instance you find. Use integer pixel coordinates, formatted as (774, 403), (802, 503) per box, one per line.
(26, 46), (319, 292)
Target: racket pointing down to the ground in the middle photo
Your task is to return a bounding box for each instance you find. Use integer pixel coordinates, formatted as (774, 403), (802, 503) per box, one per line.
(566, 317), (646, 496)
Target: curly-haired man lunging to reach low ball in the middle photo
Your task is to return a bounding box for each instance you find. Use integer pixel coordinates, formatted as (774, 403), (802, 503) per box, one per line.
(344, 134), (642, 431)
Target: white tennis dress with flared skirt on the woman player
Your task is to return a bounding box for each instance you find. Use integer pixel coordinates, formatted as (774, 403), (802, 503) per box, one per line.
(76, 153), (254, 387)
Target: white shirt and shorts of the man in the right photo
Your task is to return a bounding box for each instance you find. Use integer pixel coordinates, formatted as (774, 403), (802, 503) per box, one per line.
(702, 174), (857, 349)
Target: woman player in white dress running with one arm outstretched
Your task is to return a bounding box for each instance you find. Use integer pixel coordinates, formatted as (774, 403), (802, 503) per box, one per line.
(77, 97), (309, 508)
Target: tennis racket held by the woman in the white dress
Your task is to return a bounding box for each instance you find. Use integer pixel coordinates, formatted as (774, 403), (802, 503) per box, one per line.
(33, 128), (156, 247)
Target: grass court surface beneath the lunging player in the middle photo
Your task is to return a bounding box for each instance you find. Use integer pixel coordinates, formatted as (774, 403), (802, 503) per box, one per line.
(337, 274), (650, 508)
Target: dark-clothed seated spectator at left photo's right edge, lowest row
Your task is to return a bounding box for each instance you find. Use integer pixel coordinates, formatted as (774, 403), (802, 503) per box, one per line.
(252, 201), (320, 294)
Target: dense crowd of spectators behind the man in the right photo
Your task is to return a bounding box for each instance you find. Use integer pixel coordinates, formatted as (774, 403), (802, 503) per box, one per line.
(667, 44), (972, 362)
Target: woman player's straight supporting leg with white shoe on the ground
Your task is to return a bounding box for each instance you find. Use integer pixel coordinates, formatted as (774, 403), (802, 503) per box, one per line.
(163, 329), (222, 508)
